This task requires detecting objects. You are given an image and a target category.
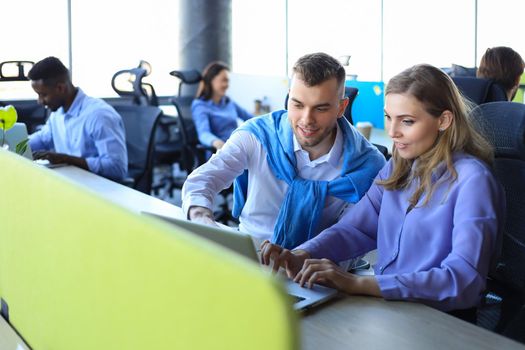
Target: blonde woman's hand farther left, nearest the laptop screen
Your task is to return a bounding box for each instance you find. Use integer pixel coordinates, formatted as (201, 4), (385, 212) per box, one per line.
(261, 240), (310, 278)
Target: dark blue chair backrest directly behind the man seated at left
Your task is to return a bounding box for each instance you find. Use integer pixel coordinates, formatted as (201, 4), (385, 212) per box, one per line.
(110, 105), (162, 194)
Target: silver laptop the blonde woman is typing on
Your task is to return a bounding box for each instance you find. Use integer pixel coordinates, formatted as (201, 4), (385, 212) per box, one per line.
(142, 212), (338, 310)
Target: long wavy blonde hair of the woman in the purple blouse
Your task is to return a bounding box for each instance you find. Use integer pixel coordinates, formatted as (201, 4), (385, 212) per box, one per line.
(378, 64), (494, 207)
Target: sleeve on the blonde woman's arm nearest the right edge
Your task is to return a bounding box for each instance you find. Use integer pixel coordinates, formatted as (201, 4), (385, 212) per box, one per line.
(376, 171), (504, 311)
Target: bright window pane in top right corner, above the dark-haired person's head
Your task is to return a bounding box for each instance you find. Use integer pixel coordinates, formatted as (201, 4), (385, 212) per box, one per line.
(477, 0), (525, 65)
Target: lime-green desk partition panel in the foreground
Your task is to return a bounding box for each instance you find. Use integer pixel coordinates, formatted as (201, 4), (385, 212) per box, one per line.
(0, 150), (298, 350)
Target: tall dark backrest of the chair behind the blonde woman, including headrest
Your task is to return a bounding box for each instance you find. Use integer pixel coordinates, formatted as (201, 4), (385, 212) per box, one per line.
(473, 102), (525, 293)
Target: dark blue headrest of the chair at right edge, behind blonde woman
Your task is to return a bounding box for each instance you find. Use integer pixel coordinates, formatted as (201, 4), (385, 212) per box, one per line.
(473, 102), (525, 160)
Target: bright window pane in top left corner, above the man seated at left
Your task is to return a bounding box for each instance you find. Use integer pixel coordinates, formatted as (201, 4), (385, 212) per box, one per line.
(0, 0), (68, 100)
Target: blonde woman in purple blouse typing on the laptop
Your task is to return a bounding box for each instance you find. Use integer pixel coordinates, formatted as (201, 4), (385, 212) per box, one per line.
(261, 65), (505, 312)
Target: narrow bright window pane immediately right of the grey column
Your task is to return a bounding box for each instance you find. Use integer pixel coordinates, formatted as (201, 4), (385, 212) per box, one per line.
(232, 0), (286, 76)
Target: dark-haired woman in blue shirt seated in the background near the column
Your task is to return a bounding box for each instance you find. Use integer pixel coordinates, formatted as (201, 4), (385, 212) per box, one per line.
(191, 61), (252, 149)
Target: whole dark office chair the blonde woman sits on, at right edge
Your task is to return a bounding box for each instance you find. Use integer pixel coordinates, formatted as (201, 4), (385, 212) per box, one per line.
(473, 102), (525, 342)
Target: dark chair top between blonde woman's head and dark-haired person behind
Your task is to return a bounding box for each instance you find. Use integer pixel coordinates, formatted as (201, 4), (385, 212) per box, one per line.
(452, 77), (507, 105)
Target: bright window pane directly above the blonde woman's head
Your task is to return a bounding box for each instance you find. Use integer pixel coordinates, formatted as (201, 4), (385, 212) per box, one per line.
(383, 0), (476, 81)
